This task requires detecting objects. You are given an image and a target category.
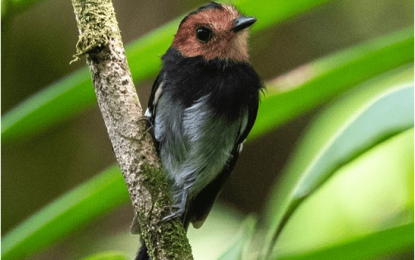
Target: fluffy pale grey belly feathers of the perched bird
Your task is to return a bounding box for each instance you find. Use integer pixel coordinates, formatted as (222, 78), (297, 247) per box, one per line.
(154, 95), (242, 203)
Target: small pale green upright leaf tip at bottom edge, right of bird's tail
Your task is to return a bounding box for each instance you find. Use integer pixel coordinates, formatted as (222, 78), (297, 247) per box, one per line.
(218, 216), (257, 260)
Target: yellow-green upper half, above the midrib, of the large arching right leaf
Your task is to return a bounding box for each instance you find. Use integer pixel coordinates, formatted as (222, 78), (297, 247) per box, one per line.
(266, 65), (414, 228)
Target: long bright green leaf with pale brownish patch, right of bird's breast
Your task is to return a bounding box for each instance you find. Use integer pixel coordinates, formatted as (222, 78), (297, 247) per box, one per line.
(249, 28), (414, 138)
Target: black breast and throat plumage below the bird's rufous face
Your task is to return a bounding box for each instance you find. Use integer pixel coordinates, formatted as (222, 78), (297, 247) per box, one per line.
(162, 48), (262, 120)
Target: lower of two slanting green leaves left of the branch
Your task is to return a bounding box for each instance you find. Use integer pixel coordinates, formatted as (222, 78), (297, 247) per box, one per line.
(1, 166), (129, 260)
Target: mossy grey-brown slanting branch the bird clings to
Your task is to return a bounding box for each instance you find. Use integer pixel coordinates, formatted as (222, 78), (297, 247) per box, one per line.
(72, 0), (192, 260)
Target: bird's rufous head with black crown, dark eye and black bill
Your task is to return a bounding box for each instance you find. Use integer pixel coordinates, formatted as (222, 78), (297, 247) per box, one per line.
(172, 2), (256, 61)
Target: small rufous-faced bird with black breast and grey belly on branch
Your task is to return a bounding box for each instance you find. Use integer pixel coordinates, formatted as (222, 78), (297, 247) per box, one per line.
(136, 2), (263, 259)
